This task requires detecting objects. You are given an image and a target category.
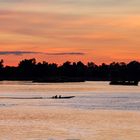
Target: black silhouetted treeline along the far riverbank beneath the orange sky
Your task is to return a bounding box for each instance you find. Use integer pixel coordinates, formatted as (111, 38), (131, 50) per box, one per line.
(0, 58), (140, 81)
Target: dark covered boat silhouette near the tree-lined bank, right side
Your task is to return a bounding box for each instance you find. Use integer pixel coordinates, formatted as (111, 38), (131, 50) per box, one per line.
(109, 81), (139, 86)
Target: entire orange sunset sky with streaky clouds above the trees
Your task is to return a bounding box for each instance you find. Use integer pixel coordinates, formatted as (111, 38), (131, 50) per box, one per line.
(0, 0), (140, 65)
